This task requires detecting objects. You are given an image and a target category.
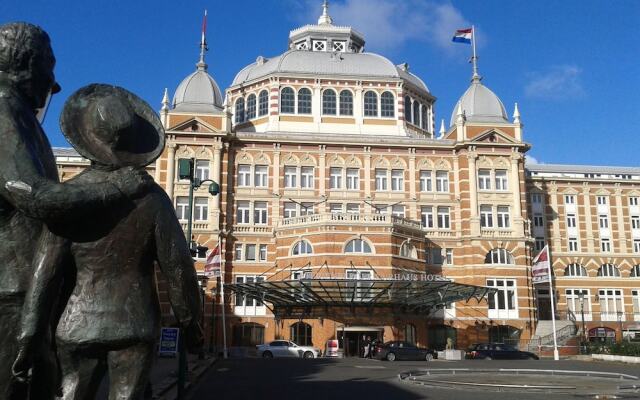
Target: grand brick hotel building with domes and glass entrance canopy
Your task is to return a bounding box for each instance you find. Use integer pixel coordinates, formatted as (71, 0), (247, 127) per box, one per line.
(55, 8), (640, 355)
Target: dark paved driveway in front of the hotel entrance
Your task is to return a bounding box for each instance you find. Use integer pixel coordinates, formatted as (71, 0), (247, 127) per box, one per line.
(185, 358), (640, 400)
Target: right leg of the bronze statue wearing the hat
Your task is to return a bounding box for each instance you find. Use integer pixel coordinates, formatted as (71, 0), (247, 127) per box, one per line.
(107, 343), (155, 400)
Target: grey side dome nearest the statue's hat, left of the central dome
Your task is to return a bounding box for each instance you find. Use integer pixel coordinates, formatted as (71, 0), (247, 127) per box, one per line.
(173, 68), (223, 113)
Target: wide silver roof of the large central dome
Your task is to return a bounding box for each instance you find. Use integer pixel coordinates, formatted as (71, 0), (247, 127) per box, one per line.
(231, 50), (429, 93)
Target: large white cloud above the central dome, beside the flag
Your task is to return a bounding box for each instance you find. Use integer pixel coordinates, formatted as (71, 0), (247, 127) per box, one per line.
(291, 0), (482, 53)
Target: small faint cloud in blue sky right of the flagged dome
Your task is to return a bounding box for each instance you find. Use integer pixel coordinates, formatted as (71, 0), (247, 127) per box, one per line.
(524, 65), (585, 100)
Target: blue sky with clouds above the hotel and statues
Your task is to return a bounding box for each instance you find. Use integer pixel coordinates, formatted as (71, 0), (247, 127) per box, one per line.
(0, 0), (640, 166)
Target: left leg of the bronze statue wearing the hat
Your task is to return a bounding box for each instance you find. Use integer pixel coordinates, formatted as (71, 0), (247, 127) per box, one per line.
(58, 342), (107, 400)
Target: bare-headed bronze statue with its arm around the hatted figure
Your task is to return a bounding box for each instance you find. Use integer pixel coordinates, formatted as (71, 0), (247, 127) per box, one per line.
(0, 23), (151, 399)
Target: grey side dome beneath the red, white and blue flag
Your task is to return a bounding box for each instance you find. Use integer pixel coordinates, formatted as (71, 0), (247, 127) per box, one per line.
(449, 78), (509, 126)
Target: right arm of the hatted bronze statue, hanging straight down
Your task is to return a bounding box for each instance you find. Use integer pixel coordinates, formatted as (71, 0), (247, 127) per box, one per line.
(155, 192), (201, 327)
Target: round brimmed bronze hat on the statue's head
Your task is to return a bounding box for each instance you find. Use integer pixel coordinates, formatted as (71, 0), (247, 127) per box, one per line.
(60, 83), (165, 167)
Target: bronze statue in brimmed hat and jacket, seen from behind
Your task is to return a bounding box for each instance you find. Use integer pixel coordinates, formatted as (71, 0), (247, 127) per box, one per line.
(16, 84), (203, 399)
